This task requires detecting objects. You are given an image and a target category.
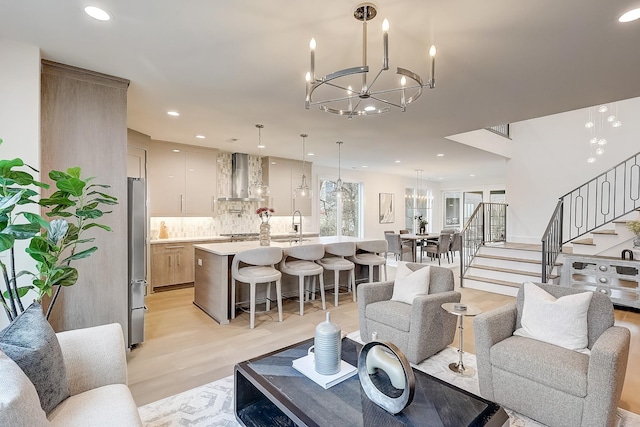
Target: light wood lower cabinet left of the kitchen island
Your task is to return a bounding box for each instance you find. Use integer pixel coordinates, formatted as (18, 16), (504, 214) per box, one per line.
(151, 243), (195, 289)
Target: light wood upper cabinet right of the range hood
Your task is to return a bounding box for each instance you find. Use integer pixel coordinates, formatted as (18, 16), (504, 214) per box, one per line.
(262, 156), (315, 216)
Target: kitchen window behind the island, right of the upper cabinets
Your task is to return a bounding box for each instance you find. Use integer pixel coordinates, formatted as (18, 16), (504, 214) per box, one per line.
(320, 180), (362, 237)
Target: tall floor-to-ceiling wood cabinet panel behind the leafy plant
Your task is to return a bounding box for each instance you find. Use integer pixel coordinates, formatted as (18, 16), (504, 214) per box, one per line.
(40, 60), (129, 342)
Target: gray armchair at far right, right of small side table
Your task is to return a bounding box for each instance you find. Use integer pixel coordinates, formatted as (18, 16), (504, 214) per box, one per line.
(473, 285), (630, 427)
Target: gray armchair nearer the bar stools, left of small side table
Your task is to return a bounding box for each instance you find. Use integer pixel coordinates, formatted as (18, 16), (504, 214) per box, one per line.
(358, 263), (460, 363)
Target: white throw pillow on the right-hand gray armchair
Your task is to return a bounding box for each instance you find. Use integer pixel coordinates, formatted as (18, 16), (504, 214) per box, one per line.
(513, 282), (593, 353)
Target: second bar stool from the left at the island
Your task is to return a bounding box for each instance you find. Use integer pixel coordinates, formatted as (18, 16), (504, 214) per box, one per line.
(280, 244), (326, 316)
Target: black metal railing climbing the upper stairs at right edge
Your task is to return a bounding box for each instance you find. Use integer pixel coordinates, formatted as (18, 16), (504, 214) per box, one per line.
(541, 153), (640, 283)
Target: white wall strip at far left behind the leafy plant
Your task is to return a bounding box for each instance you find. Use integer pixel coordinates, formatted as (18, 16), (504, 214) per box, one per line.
(0, 39), (40, 328)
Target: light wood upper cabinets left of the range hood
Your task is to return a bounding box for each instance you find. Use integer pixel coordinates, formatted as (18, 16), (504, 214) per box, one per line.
(147, 141), (218, 216)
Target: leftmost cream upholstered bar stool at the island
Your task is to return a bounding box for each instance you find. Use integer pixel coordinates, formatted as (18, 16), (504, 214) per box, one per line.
(231, 247), (282, 329)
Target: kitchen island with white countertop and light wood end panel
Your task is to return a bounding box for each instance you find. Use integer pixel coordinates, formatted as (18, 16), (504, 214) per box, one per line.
(193, 236), (375, 325)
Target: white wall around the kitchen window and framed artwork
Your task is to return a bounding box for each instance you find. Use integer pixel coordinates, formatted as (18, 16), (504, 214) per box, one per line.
(313, 165), (442, 239)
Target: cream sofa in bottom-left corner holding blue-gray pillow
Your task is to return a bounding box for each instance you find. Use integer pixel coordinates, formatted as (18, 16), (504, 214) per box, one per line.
(0, 323), (142, 427)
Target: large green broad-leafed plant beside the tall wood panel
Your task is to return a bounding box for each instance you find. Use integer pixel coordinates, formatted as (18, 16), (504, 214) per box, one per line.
(0, 139), (118, 321)
